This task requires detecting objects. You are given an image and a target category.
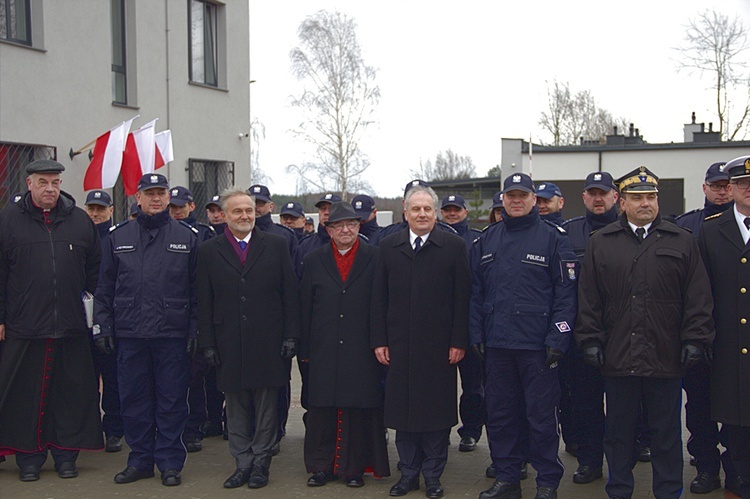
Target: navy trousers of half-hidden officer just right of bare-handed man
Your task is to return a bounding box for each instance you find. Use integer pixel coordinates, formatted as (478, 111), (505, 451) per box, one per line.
(458, 352), (487, 441)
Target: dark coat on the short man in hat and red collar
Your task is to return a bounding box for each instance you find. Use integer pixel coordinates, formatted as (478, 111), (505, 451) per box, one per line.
(300, 241), (383, 408)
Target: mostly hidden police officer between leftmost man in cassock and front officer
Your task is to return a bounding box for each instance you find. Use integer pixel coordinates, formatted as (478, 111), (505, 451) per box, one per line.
(85, 190), (123, 452)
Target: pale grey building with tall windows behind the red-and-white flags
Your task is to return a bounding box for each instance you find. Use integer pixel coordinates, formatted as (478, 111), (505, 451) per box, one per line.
(0, 0), (250, 220)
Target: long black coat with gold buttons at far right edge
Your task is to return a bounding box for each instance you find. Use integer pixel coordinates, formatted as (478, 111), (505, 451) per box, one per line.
(698, 210), (750, 426)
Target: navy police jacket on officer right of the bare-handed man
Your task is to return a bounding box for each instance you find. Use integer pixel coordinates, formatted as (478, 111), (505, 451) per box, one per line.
(469, 207), (578, 352)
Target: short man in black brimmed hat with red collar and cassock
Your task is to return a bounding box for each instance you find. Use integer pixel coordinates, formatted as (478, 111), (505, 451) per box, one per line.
(300, 201), (391, 487)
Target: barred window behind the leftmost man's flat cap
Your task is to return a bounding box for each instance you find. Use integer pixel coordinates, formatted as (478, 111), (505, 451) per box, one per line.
(0, 142), (57, 208)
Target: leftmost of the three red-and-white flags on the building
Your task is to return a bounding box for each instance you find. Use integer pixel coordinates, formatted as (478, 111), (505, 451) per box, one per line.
(83, 116), (138, 191)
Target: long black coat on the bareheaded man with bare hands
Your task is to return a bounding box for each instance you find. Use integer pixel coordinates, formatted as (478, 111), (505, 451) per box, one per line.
(370, 228), (471, 432)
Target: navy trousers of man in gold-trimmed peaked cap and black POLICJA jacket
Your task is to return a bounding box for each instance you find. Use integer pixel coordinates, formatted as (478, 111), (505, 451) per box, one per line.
(604, 376), (683, 499)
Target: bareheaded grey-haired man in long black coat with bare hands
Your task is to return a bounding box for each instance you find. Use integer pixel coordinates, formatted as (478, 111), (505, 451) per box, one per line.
(370, 185), (471, 497)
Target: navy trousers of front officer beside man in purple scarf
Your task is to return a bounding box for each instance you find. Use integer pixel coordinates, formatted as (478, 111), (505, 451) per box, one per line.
(117, 338), (190, 471)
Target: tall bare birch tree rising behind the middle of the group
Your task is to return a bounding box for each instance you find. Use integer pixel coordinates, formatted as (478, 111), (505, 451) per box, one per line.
(287, 10), (380, 199)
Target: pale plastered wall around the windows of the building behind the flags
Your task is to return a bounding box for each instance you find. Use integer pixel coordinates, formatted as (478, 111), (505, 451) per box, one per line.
(0, 0), (250, 202)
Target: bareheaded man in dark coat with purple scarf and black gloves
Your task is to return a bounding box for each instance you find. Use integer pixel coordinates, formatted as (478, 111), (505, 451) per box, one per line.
(197, 188), (299, 488)
